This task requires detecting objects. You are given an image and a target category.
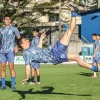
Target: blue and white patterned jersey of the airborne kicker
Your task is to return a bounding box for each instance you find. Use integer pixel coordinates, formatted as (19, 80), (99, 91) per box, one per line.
(23, 46), (56, 64)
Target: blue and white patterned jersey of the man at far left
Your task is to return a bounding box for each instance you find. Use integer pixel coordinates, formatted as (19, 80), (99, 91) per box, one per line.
(0, 25), (20, 53)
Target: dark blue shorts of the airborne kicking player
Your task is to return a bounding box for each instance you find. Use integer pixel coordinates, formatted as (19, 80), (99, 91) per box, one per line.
(51, 41), (68, 64)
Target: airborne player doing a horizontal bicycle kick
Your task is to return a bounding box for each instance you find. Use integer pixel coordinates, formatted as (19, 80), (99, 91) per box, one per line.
(18, 6), (99, 82)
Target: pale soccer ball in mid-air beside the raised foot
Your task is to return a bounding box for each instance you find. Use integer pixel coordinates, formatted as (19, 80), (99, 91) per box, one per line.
(60, 9), (71, 23)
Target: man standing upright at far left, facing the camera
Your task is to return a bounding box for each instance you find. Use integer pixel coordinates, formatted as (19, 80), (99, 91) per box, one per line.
(0, 15), (20, 90)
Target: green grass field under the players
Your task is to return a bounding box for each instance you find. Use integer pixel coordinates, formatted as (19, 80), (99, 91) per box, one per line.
(0, 64), (100, 100)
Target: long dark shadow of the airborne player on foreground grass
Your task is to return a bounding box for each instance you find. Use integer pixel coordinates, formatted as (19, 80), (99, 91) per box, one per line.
(13, 86), (91, 100)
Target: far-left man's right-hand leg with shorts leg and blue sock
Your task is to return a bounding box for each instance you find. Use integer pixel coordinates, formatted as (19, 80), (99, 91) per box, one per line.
(7, 52), (16, 90)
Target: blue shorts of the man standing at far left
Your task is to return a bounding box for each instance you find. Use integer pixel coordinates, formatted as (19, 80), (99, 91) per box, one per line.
(0, 52), (15, 63)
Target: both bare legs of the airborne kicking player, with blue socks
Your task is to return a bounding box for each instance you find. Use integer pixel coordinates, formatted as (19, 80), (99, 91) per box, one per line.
(60, 7), (98, 72)
